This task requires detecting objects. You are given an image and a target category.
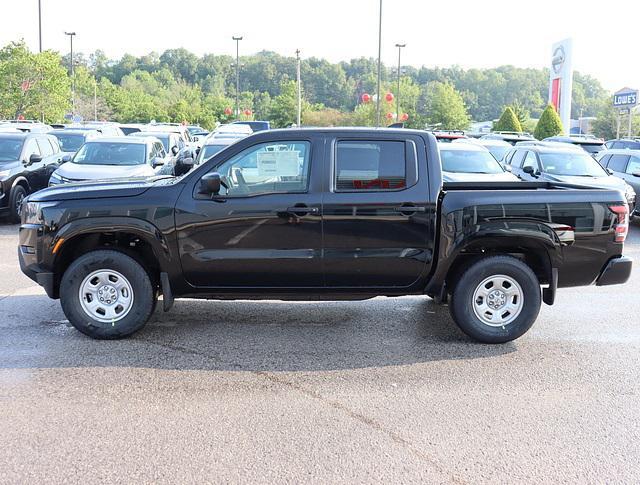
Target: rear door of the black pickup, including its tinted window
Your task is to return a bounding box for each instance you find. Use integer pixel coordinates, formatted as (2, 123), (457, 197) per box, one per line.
(322, 133), (433, 288)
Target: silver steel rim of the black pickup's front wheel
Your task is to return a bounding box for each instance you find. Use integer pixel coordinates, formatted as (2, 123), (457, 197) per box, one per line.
(78, 269), (133, 324)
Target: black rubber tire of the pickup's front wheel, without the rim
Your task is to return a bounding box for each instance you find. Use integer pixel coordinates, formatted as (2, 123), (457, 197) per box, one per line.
(60, 250), (156, 339)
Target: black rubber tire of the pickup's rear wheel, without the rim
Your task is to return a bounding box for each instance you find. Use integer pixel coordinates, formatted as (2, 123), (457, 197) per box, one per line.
(449, 256), (541, 344)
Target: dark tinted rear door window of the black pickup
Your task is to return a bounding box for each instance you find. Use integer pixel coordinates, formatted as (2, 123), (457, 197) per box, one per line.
(335, 140), (407, 192)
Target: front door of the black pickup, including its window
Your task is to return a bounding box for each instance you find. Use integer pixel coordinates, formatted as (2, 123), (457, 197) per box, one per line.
(176, 138), (323, 289)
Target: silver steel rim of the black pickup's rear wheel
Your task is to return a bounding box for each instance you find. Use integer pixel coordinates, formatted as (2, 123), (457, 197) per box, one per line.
(472, 275), (524, 327)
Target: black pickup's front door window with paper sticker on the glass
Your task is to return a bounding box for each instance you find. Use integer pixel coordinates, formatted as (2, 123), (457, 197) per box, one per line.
(214, 141), (311, 197)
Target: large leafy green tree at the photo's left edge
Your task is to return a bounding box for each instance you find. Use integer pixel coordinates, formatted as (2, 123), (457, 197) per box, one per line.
(0, 42), (71, 123)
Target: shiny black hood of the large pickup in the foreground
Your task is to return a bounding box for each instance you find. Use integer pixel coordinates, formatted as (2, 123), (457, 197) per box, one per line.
(29, 177), (166, 202)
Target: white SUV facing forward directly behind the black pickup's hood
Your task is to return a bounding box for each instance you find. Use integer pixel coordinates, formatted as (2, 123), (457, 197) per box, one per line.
(49, 136), (182, 185)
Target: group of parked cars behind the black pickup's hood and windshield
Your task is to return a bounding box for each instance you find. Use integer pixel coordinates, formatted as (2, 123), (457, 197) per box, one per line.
(0, 120), (262, 222)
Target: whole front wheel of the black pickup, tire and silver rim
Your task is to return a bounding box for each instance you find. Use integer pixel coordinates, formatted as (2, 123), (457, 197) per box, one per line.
(60, 250), (156, 339)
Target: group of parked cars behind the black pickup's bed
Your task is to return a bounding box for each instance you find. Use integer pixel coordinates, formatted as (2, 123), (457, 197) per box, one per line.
(434, 132), (640, 215)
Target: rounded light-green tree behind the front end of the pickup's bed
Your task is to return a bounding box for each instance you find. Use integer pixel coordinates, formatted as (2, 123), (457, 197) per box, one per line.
(425, 81), (469, 130)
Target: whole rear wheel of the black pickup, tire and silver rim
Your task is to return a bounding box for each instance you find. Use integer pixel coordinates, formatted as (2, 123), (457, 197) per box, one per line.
(449, 256), (541, 344)
